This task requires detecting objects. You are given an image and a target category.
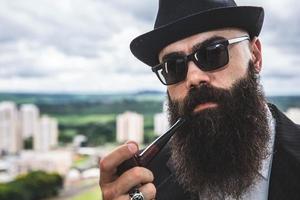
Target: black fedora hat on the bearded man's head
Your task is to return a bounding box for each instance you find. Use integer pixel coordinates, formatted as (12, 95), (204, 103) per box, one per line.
(130, 0), (264, 66)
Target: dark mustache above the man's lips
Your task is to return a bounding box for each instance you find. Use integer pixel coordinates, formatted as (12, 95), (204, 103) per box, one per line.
(177, 84), (232, 115)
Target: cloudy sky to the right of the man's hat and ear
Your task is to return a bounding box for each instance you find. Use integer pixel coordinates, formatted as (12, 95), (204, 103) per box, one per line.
(238, 0), (300, 95)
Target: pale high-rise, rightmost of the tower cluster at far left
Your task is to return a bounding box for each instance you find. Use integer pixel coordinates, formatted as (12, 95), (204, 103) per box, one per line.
(33, 116), (58, 151)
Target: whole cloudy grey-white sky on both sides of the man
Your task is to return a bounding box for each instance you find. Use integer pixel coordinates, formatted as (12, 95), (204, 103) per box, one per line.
(0, 0), (300, 95)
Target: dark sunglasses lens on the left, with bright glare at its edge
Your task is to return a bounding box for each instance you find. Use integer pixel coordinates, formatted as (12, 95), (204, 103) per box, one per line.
(156, 58), (186, 85)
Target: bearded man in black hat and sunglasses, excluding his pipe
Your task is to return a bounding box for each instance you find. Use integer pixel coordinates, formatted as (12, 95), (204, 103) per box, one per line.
(100, 0), (300, 200)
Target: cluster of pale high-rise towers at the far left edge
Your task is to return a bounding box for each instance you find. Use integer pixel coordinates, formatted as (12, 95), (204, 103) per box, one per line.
(0, 101), (59, 154)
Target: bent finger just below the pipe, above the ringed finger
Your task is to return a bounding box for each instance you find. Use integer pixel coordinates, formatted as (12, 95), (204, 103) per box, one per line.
(115, 167), (154, 194)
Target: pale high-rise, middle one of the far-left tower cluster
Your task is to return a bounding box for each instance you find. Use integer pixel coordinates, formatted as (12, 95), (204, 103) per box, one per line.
(20, 104), (39, 139)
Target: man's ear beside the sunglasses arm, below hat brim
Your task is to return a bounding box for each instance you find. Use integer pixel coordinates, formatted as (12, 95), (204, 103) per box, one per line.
(250, 37), (262, 73)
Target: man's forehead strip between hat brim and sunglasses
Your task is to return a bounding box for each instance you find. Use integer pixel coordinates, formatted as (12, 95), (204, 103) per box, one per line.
(159, 28), (248, 60)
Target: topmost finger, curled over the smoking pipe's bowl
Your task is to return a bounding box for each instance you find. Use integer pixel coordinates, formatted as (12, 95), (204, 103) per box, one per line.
(99, 142), (138, 184)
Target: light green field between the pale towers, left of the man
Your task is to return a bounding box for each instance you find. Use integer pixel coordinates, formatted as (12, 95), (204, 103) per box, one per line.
(54, 111), (155, 146)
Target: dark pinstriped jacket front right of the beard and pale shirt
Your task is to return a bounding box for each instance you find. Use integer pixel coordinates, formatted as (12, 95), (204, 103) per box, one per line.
(269, 105), (300, 200)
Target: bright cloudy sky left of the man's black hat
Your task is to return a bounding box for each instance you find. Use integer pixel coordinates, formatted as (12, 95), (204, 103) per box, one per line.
(0, 0), (159, 92)
